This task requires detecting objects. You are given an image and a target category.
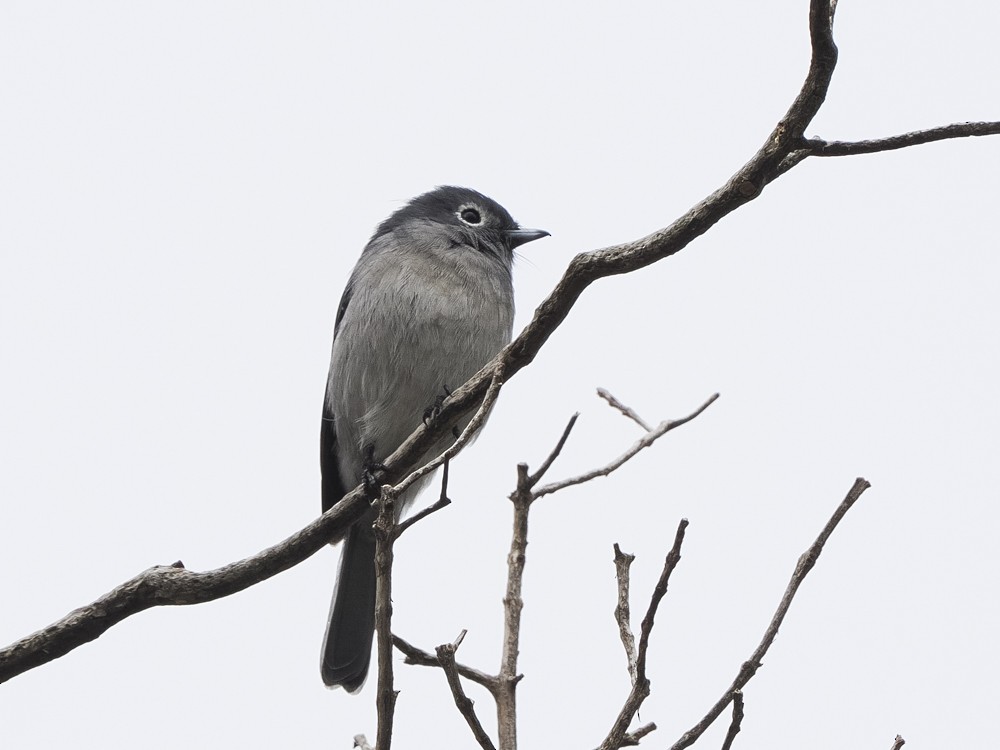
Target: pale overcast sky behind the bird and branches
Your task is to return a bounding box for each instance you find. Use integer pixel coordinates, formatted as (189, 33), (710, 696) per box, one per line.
(0, 0), (1000, 749)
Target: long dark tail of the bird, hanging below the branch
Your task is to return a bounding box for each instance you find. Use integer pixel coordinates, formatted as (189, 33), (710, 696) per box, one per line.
(320, 521), (375, 693)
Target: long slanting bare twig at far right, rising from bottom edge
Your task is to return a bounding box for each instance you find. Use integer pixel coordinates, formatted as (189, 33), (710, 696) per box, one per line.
(670, 477), (871, 750)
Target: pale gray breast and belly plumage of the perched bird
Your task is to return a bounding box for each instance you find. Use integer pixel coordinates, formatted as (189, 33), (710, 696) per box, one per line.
(329, 233), (514, 500)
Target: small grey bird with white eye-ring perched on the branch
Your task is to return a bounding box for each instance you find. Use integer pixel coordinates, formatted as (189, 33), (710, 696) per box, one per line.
(320, 186), (549, 693)
